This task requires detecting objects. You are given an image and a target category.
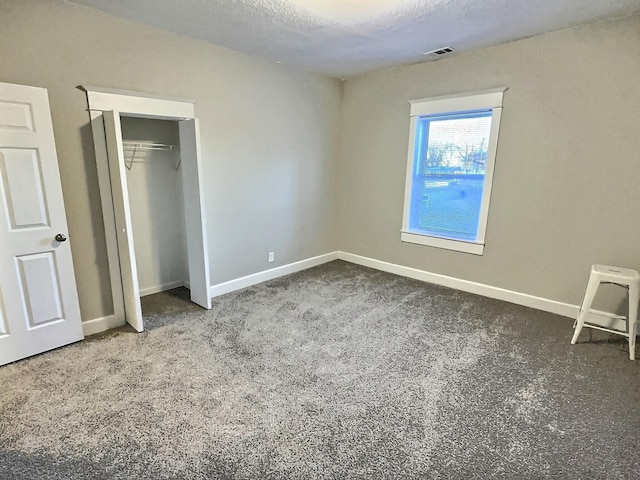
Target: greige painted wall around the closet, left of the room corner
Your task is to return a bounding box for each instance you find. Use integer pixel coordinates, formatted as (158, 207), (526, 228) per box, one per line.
(0, 0), (342, 320)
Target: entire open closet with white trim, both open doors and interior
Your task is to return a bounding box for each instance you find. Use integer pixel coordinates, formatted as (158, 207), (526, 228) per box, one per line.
(82, 87), (211, 334)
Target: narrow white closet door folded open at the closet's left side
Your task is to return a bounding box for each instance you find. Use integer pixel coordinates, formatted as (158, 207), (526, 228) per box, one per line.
(102, 111), (144, 332)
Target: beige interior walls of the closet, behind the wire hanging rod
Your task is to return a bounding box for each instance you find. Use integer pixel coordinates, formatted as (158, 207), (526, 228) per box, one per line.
(121, 117), (189, 296)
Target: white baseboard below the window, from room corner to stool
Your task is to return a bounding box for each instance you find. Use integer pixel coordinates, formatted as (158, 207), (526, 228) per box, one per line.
(338, 252), (579, 318)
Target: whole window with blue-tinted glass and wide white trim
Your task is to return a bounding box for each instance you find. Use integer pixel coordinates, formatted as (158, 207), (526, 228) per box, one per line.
(401, 88), (506, 255)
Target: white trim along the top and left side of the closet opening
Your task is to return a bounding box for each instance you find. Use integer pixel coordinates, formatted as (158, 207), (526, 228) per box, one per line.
(78, 85), (202, 326)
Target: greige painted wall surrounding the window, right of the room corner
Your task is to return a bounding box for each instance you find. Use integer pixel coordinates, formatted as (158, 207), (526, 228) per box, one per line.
(338, 16), (640, 304)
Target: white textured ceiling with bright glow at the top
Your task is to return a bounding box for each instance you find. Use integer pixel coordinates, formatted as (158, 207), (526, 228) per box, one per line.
(70, 0), (640, 78)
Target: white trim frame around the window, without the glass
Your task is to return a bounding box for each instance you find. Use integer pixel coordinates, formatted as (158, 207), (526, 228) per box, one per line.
(400, 87), (507, 255)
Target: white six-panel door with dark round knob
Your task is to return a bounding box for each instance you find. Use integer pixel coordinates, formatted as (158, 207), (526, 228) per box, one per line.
(0, 83), (83, 365)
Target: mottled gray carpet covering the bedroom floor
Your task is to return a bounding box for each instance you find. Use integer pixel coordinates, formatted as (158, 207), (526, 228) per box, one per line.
(0, 261), (640, 480)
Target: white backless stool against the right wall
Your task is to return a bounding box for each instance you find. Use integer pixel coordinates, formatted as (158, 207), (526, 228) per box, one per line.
(571, 265), (640, 360)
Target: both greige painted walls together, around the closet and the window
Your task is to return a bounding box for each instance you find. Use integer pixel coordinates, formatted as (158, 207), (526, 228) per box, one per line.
(0, 0), (640, 326)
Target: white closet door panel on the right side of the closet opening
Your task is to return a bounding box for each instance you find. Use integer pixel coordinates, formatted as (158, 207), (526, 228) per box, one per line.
(180, 118), (211, 309)
